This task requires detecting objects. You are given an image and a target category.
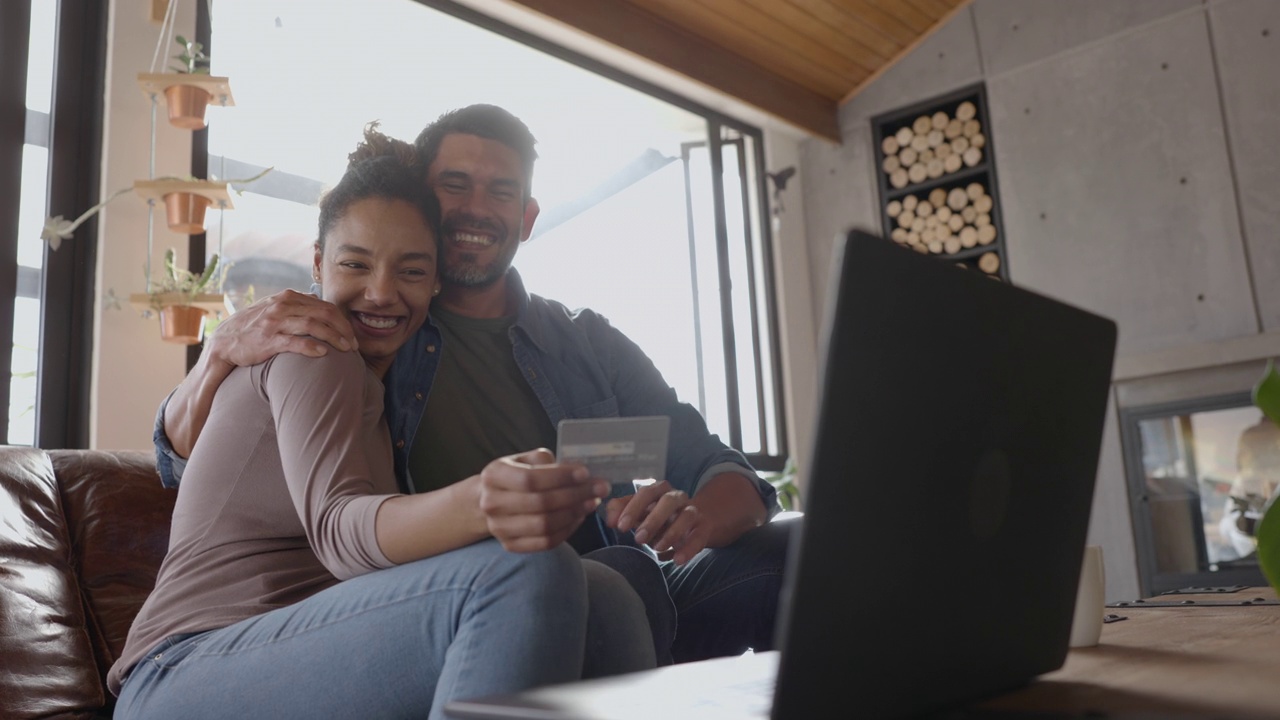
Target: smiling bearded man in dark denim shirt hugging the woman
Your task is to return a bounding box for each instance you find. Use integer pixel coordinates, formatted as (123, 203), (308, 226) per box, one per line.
(156, 105), (788, 661)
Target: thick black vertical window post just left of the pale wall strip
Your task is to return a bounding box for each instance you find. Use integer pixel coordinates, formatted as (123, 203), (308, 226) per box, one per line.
(36, 0), (108, 448)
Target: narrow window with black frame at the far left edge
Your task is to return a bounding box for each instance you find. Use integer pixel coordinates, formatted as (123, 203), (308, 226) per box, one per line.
(0, 0), (106, 447)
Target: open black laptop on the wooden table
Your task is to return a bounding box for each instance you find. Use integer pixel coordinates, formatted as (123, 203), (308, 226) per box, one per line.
(447, 231), (1116, 720)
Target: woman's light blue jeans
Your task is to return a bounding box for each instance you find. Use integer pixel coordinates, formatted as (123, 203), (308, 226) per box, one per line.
(115, 539), (588, 719)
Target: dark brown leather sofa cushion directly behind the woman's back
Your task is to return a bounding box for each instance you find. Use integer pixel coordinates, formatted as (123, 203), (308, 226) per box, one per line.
(49, 450), (178, 696)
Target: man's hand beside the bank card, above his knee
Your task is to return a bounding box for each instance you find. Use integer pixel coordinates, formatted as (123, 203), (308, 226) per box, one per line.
(604, 480), (710, 565)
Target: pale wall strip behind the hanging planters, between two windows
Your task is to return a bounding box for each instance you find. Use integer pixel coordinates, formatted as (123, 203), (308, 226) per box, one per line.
(90, 0), (199, 450)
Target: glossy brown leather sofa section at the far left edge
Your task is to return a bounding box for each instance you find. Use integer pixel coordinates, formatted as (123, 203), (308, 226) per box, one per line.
(0, 447), (106, 720)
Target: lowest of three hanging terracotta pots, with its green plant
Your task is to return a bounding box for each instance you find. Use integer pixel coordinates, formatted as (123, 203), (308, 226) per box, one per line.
(147, 247), (227, 345)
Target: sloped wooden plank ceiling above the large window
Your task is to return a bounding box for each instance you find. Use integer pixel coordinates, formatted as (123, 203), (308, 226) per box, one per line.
(499, 0), (970, 141)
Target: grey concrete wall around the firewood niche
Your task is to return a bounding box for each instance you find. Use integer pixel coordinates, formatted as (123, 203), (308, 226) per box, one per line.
(801, 0), (1280, 600)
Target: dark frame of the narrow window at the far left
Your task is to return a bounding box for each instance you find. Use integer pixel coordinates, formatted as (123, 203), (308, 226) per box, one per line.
(0, 0), (109, 448)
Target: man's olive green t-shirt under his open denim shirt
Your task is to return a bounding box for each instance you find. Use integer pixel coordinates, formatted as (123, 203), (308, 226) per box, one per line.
(408, 302), (556, 492)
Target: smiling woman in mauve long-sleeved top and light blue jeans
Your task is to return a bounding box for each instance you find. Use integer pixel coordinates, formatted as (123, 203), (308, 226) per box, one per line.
(108, 129), (586, 717)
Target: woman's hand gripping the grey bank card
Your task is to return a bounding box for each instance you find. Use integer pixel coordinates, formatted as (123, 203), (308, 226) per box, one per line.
(480, 448), (609, 552)
